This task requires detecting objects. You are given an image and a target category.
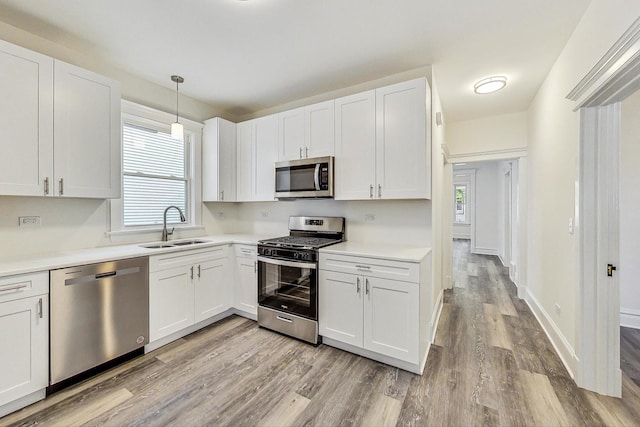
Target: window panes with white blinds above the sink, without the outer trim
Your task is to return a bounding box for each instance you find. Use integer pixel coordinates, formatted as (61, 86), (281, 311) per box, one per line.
(122, 122), (191, 227)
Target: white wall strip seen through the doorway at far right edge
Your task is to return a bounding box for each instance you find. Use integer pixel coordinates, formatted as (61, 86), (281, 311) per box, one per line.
(618, 91), (640, 328)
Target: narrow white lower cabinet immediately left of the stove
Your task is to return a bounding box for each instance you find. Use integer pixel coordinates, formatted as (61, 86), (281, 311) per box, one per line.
(234, 244), (258, 317)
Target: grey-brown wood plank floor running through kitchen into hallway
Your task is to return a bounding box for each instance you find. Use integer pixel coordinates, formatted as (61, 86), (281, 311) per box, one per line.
(0, 241), (640, 426)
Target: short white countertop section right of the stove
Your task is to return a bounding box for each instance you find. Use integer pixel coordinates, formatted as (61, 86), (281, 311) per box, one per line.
(320, 242), (431, 262)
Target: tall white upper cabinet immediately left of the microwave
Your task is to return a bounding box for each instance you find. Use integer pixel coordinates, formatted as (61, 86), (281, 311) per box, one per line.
(237, 115), (278, 202)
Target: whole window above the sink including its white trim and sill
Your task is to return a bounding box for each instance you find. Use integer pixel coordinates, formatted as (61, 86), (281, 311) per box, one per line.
(108, 100), (204, 242)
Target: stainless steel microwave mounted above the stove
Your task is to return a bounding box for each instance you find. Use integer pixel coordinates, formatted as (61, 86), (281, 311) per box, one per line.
(275, 157), (333, 199)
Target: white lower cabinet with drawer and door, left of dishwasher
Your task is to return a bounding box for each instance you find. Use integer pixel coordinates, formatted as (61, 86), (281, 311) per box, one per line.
(0, 272), (49, 417)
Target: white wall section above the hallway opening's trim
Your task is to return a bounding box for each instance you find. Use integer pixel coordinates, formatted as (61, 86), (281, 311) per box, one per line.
(446, 112), (527, 156)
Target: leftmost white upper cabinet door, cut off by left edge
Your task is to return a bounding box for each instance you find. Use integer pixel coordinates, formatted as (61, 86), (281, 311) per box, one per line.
(0, 40), (53, 196)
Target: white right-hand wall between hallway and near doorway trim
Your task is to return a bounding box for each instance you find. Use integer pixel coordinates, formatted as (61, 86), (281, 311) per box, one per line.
(526, 0), (640, 370)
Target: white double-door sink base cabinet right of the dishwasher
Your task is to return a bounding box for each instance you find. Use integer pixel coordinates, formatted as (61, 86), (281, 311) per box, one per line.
(149, 245), (232, 342)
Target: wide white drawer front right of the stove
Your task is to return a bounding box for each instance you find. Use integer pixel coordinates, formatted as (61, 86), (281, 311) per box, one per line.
(319, 253), (420, 283)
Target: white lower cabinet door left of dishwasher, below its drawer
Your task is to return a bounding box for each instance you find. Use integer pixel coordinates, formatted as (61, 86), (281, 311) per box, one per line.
(0, 295), (49, 406)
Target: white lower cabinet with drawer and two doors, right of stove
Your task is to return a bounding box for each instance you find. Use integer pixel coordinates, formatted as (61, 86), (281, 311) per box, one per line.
(318, 253), (427, 372)
